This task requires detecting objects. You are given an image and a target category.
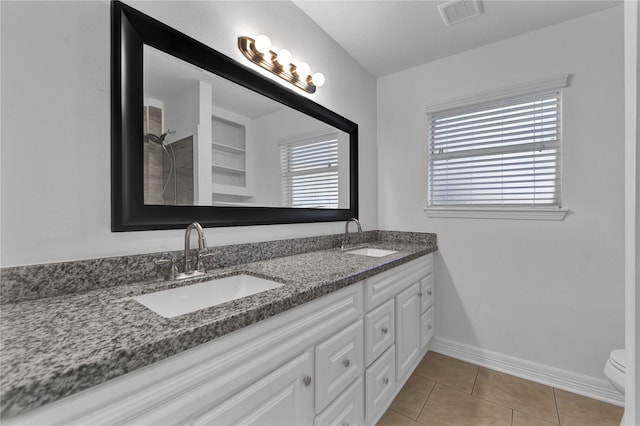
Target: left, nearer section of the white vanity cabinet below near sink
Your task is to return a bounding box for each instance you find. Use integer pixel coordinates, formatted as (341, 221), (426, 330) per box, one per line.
(3, 283), (364, 426)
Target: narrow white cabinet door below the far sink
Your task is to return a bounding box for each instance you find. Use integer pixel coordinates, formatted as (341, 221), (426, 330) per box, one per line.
(396, 282), (420, 380)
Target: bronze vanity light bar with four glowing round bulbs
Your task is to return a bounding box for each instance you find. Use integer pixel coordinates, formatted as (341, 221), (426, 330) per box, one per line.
(238, 36), (324, 93)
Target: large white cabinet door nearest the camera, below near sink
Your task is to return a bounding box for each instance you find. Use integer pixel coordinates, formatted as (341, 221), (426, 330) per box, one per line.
(191, 351), (314, 426)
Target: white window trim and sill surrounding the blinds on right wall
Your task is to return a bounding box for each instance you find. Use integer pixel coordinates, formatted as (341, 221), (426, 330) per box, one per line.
(424, 74), (570, 220)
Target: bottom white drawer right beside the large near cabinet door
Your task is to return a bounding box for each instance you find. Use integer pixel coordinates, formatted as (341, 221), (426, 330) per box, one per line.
(314, 377), (364, 426)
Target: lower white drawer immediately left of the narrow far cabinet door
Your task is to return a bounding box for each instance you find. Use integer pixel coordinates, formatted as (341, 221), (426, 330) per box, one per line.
(365, 345), (396, 424)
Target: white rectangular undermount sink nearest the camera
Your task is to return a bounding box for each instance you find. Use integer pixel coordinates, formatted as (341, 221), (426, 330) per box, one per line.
(132, 274), (283, 318)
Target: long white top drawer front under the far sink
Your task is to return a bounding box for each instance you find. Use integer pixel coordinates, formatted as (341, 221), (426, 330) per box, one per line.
(364, 254), (433, 311)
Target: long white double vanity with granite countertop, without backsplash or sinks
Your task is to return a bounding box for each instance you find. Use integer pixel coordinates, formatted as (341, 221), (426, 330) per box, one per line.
(2, 233), (437, 425)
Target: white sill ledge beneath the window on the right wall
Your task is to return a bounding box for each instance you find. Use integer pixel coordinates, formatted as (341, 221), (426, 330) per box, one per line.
(424, 207), (569, 220)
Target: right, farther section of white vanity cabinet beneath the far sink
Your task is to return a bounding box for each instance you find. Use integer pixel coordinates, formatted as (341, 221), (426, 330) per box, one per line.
(364, 254), (435, 424)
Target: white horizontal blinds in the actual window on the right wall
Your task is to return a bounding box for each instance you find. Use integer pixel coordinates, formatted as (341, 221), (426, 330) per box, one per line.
(428, 90), (560, 207)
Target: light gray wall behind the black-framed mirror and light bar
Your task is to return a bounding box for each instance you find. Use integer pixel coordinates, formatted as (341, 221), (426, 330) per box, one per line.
(0, 0), (377, 266)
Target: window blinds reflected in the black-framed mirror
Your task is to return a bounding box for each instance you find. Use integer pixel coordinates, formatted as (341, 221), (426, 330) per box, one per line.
(280, 132), (338, 208)
